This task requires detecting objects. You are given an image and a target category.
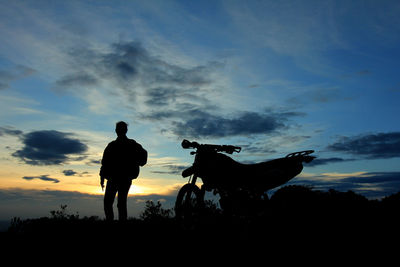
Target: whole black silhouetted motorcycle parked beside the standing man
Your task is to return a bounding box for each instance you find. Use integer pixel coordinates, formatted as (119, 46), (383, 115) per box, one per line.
(175, 139), (315, 219)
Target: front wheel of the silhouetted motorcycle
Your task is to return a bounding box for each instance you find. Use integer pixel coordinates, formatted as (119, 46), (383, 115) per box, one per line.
(175, 184), (204, 221)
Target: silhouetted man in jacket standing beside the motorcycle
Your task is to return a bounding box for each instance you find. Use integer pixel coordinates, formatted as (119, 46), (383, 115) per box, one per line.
(100, 121), (147, 221)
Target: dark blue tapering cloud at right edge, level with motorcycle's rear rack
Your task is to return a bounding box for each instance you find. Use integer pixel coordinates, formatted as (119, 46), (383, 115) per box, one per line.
(328, 132), (400, 159)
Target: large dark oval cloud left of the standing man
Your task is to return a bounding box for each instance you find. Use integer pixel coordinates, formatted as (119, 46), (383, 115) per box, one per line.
(12, 130), (88, 165)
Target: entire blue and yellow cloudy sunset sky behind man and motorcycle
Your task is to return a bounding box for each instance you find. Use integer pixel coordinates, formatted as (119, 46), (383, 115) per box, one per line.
(0, 0), (400, 220)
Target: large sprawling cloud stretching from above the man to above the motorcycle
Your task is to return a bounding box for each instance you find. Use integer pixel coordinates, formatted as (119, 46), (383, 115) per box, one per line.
(56, 42), (299, 138)
